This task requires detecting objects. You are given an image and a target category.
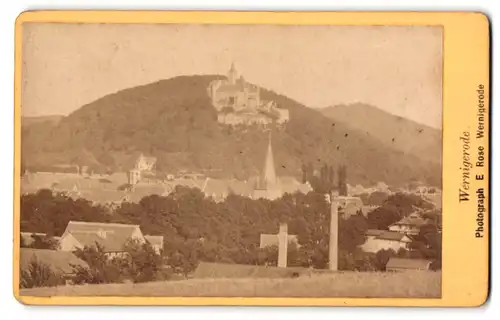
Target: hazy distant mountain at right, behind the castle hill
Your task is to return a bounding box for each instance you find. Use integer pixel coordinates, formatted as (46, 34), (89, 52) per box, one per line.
(320, 103), (442, 164)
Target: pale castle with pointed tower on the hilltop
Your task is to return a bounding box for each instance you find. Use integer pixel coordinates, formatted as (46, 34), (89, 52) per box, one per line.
(208, 63), (290, 125)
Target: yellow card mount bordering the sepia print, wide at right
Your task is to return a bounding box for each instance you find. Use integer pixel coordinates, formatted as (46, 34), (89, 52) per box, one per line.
(13, 11), (490, 307)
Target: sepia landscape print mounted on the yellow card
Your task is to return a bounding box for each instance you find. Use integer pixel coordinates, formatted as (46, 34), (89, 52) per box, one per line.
(16, 22), (443, 298)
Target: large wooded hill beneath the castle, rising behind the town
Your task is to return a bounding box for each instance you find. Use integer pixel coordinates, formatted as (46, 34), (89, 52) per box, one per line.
(22, 76), (441, 185)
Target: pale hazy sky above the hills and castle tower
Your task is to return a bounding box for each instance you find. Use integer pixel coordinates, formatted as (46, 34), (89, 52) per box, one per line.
(22, 23), (442, 128)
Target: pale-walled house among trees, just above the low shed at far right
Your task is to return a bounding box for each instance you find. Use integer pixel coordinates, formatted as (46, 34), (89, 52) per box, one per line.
(360, 229), (413, 253)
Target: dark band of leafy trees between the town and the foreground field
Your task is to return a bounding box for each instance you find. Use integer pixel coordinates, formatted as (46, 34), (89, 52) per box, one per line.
(21, 187), (441, 274)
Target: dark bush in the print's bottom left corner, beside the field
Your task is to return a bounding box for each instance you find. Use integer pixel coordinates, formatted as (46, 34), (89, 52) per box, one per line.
(20, 255), (64, 288)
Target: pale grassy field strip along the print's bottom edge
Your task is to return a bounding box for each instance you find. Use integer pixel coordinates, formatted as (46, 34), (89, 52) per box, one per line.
(20, 271), (441, 298)
